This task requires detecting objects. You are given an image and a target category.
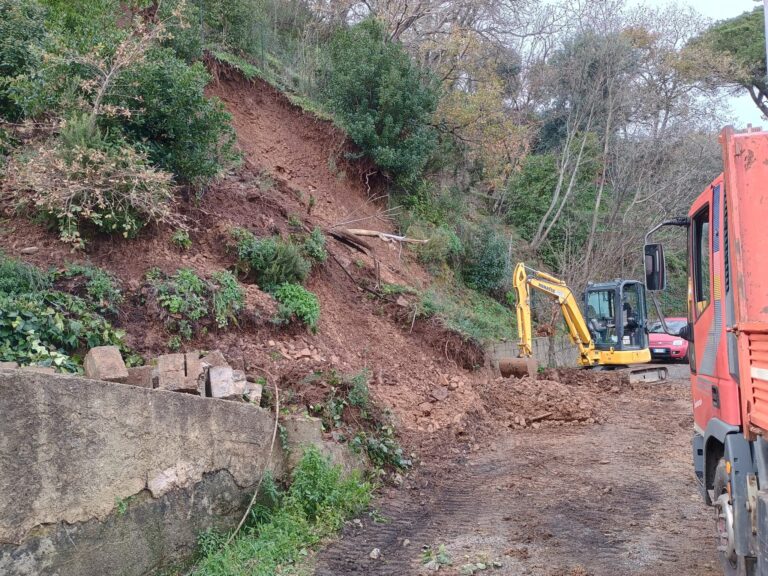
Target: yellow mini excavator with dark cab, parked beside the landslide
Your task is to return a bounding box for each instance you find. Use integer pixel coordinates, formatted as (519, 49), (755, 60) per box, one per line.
(499, 262), (667, 381)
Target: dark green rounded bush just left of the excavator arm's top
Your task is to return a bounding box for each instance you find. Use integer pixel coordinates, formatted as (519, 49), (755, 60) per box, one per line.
(461, 225), (511, 294)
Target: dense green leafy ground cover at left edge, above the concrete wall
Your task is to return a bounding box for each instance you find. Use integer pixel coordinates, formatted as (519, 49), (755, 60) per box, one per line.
(0, 254), (130, 372)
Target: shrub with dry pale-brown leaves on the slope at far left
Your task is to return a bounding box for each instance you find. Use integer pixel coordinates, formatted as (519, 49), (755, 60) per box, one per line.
(3, 118), (177, 247)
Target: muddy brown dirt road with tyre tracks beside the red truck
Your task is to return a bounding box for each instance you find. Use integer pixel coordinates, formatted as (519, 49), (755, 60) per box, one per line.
(315, 370), (720, 576)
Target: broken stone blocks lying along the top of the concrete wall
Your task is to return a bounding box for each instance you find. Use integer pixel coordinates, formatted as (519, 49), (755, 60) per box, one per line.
(0, 346), (263, 406)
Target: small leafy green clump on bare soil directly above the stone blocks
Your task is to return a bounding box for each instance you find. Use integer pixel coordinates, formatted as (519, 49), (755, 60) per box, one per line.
(147, 268), (245, 347)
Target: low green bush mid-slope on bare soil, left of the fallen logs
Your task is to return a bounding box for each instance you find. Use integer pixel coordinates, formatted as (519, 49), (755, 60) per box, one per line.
(232, 228), (312, 292)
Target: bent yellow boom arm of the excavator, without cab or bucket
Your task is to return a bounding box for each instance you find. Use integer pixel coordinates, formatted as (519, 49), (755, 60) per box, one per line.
(512, 262), (595, 365)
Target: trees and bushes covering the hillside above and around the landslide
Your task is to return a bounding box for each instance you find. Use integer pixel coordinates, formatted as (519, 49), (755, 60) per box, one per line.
(0, 0), (724, 320)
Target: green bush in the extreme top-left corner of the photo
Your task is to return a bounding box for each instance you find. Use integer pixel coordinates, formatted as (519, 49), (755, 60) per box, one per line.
(0, 0), (46, 120)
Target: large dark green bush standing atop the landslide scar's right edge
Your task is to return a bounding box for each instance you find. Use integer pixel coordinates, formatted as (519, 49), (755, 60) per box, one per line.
(326, 19), (437, 182)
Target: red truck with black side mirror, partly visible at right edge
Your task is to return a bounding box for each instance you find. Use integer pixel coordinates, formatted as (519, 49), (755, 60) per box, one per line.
(644, 128), (768, 576)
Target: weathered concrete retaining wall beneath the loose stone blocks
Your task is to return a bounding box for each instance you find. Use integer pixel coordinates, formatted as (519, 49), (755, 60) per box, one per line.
(0, 371), (292, 576)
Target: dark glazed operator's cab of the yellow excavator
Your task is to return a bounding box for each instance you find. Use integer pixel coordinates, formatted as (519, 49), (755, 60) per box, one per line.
(584, 280), (648, 351)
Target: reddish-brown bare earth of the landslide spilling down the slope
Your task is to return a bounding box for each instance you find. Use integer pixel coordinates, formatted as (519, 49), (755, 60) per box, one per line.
(0, 63), (487, 450)
